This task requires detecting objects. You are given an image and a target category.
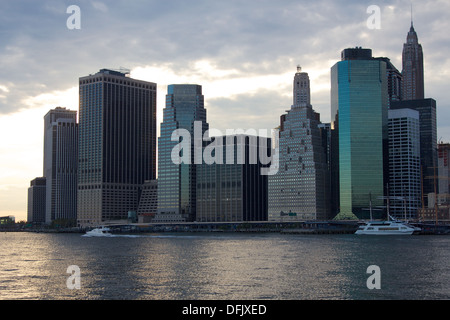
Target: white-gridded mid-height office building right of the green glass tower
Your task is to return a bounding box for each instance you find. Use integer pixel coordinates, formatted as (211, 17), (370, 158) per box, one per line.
(389, 109), (422, 220)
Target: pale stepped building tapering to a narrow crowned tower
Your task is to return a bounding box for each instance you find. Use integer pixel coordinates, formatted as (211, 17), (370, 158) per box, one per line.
(268, 67), (330, 221)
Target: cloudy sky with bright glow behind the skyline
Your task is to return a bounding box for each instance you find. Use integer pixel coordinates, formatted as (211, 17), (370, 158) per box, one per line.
(0, 0), (450, 221)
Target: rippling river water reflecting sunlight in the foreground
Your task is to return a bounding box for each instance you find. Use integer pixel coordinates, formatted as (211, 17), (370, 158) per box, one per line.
(0, 232), (450, 300)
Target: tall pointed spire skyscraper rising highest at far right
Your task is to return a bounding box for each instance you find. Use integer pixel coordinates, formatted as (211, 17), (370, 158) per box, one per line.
(402, 20), (425, 100)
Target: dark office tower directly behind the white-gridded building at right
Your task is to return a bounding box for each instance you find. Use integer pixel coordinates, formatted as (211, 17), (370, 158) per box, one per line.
(391, 98), (439, 207)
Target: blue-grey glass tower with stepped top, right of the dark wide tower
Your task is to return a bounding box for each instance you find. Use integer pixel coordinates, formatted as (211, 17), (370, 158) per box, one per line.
(155, 84), (208, 221)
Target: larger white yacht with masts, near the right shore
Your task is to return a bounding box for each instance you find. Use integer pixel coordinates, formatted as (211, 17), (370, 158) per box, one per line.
(355, 220), (420, 235)
